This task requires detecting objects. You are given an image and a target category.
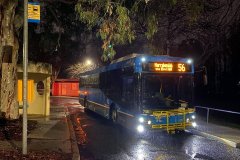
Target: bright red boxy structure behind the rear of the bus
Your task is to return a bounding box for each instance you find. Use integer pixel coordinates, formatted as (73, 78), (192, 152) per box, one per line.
(52, 79), (79, 97)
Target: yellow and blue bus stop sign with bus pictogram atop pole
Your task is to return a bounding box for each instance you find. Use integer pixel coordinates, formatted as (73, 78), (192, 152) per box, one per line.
(28, 2), (40, 23)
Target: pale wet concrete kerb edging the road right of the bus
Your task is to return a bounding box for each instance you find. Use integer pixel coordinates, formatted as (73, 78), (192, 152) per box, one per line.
(188, 129), (240, 148)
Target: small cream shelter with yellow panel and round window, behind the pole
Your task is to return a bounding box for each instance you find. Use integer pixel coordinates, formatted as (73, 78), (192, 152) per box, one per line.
(17, 63), (52, 116)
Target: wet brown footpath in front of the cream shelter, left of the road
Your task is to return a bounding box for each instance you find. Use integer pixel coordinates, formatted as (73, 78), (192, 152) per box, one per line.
(0, 97), (80, 160)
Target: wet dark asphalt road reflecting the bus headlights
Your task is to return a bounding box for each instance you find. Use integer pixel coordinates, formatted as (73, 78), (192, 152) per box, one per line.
(51, 99), (240, 160)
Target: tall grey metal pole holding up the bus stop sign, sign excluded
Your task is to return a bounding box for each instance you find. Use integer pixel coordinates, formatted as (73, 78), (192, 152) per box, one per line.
(22, 0), (28, 155)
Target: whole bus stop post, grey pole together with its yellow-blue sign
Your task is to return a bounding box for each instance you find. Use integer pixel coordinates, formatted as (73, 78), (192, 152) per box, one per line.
(22, 0), (40, 155)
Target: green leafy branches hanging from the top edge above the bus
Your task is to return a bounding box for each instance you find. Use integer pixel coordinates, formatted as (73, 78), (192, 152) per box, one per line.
(75, 0), (203, 61)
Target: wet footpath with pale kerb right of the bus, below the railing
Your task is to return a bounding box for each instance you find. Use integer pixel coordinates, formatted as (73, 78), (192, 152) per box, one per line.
(188, 120), (240, 148)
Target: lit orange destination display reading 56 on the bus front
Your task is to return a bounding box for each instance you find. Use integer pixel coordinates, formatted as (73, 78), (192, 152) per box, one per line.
(143, 62), (191, 72)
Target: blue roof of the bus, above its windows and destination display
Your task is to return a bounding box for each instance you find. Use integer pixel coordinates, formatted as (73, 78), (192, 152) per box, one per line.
(80, 53), (193, 76)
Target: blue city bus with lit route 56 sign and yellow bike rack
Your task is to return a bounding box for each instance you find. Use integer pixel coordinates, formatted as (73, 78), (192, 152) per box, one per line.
(79, 54), (196, 133)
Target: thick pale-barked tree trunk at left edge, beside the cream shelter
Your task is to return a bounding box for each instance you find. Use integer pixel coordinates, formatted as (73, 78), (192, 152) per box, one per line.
(0, 0), (19, 119)
